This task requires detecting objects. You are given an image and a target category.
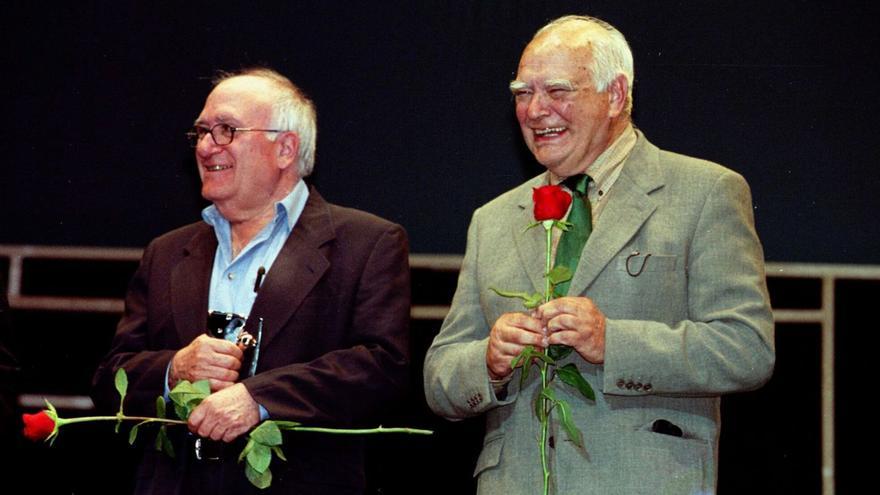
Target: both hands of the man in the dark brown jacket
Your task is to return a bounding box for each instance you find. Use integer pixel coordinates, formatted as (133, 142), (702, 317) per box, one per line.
(169, 335), (260, 442)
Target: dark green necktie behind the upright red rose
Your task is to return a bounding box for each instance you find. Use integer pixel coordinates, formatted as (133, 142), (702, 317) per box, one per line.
(556, 174), (593, 295)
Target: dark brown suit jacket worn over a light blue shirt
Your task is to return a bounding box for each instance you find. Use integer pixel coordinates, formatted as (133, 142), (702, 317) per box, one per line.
(94, 189), (410, 495)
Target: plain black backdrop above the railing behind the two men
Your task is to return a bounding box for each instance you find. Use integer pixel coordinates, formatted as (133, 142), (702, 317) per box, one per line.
(0, 0), (880, 263)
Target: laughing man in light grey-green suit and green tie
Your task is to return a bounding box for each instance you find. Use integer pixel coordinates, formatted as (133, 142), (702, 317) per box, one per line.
(425, 16), (775, 495)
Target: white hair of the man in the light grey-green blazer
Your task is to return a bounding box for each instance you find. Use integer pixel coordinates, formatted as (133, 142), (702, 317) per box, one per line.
(532, 15), (635, 114)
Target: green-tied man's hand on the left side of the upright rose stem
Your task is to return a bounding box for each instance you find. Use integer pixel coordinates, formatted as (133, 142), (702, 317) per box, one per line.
(486, 313), (547, 380)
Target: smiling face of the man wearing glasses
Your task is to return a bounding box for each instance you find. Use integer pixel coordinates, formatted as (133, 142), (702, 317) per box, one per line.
(196, 76), (298, 221)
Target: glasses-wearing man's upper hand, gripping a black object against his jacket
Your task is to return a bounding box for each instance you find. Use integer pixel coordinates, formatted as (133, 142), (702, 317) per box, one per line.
(168, 335), (242, 392)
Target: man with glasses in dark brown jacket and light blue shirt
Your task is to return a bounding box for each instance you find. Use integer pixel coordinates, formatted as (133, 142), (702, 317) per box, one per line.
(94, 69), (410, 495)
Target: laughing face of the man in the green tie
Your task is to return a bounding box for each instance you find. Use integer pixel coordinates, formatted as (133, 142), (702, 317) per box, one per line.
(510, 35), (626, 177)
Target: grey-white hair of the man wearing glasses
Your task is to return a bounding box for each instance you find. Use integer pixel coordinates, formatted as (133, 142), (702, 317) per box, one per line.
(214, 67), (318, 178)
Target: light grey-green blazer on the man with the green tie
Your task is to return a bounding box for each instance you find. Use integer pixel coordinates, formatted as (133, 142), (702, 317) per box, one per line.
(425, 133), (775, 495)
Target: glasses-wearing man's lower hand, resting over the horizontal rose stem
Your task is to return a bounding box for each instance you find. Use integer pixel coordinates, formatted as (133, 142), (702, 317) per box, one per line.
(188, 383), (260, 442)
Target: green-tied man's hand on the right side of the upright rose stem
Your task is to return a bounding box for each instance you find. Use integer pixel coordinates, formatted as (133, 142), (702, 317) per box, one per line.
(535, 297), (605, 364)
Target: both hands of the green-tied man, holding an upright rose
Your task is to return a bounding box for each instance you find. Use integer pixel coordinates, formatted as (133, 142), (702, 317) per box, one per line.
(486, 297), (605, 380)
